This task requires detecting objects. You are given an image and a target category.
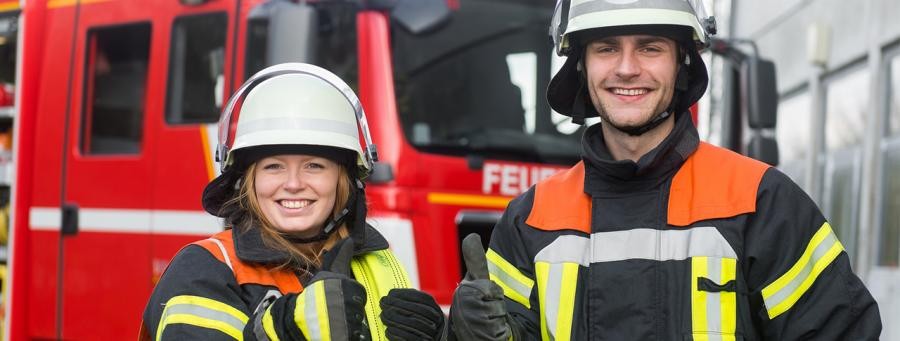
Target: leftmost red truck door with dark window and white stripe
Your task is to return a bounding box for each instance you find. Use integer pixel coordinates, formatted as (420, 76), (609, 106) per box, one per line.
(54, 20), (154, 340)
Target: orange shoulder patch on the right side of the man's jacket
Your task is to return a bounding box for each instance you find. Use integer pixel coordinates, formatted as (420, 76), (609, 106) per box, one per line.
(668, 142), (769, 226)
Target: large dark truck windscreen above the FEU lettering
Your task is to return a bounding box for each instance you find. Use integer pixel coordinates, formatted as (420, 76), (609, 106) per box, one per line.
(392, 0), (583, 164)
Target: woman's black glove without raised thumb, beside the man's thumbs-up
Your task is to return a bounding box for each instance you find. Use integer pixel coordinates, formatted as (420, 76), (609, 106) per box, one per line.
(380, 289), (447, 341)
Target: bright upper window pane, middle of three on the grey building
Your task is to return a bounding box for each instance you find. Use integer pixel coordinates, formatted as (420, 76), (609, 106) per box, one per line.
(825, 68), (870, 150)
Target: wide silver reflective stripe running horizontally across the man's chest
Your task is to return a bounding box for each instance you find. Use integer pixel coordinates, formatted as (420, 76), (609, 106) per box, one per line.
(534, 227), (737, 266)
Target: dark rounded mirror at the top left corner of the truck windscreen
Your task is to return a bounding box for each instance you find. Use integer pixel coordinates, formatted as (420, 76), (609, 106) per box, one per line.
(391, 0), (450, 34)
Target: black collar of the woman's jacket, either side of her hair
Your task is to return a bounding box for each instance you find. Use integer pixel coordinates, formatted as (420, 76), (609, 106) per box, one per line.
(232, 224), (388, 264)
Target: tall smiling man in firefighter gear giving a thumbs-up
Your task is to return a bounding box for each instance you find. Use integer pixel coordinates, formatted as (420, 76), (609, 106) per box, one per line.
(450, 0), (881, 340)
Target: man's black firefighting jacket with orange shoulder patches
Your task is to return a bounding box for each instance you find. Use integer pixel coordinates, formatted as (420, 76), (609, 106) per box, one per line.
(487, 115), (881, 340)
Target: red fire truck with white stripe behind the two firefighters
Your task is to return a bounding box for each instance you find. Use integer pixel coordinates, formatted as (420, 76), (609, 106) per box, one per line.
(0, 0), (580, 340)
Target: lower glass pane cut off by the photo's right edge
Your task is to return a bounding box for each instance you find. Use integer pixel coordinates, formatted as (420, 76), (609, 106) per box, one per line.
(877, 139), (900, 267)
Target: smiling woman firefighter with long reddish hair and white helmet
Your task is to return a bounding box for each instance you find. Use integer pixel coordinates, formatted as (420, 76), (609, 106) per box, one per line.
(141, 63), (446, 340)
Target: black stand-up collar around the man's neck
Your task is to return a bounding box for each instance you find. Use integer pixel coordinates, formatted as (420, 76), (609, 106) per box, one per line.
(581, 112), (700, 196)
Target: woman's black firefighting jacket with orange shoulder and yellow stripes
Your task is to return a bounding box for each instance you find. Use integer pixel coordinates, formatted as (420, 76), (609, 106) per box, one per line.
(140, 225), (409, 340)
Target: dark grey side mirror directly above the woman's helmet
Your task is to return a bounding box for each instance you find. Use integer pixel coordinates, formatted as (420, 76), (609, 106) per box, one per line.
(248, 1), (318, 66)
